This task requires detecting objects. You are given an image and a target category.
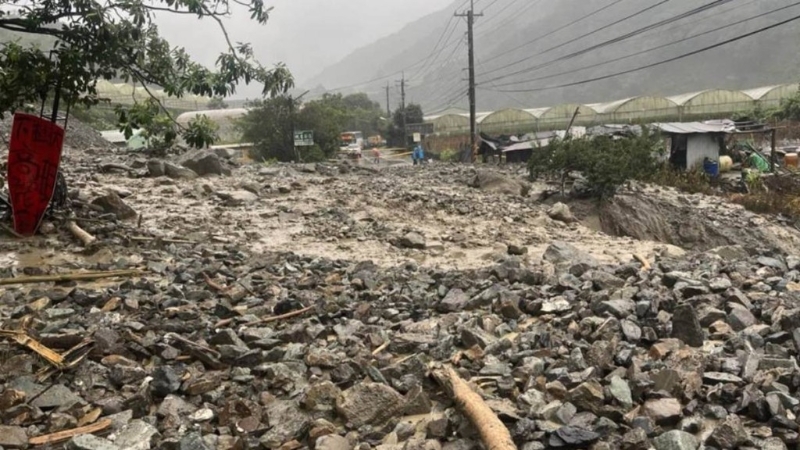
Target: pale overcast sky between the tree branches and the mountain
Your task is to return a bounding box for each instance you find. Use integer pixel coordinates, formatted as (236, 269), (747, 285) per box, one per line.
(157, 0), (452, 98)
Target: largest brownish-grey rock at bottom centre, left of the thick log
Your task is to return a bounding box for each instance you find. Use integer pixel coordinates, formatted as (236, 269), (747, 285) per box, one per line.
(336, 383), (405, 427)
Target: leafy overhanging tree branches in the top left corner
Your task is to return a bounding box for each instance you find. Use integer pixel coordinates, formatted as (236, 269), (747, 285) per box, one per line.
(0, 0), (294, 145)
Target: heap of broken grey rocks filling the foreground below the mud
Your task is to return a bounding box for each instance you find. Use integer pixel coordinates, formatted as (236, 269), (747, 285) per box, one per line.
(0, 236), (800, 450)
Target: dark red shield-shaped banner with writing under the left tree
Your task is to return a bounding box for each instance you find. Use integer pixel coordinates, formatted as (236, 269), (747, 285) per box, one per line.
(8, 113), (64, 236)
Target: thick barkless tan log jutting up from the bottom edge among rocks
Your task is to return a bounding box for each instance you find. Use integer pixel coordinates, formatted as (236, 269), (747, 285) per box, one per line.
(433, 367), (517, 450)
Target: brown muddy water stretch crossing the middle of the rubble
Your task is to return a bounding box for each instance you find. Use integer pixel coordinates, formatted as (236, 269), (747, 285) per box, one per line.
(70, 166), (688, 269)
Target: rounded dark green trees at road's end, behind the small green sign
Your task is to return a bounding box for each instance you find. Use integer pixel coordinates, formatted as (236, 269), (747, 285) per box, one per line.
(239, 94), (381, 161)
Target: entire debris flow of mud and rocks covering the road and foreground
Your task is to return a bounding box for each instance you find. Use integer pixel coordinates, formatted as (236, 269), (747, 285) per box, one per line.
(0, 134), (800, 450)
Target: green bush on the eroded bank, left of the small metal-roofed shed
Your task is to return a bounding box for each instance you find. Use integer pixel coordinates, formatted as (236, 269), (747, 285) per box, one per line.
(528, 127), (665, 198)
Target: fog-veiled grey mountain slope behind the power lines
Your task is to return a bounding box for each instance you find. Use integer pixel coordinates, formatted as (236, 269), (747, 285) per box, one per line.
(303, 0), (800, 114)
